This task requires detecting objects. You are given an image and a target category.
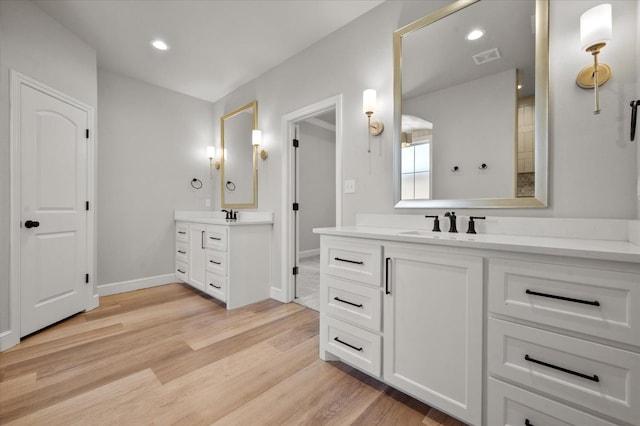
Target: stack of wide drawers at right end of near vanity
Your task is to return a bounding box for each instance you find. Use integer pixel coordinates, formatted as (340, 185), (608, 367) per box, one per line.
(487, 256), (640, 426)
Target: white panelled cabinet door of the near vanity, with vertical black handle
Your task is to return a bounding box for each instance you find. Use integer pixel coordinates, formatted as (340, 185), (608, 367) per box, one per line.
(383, 246), (483, 425)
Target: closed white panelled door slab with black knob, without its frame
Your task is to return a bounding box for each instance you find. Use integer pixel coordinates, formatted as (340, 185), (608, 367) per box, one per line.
(19, 84), (91, 337)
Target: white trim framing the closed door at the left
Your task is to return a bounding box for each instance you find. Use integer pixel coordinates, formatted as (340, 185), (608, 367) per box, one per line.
(5, 69), (97, 350)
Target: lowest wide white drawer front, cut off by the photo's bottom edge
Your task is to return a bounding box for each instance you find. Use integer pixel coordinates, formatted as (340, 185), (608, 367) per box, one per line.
(487, 378), (615, 426)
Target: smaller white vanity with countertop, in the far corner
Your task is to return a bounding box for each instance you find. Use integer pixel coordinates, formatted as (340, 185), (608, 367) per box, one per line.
(175, 212), (273, 309)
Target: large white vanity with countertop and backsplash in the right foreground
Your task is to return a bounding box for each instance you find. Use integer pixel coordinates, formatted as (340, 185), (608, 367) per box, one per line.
(315, 215), (640, 426)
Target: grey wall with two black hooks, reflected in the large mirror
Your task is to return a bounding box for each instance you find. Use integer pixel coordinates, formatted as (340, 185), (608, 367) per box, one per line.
(402, 69), (517, 199)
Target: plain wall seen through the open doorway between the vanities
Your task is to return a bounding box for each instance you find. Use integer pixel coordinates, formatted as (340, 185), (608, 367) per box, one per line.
(298, 122), (336, 251)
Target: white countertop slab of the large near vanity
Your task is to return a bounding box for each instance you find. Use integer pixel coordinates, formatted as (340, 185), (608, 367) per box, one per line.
(313, 226), (640, 263)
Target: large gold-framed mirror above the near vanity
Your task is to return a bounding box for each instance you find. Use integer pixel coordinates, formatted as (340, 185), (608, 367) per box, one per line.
(393, 0), (549, 208)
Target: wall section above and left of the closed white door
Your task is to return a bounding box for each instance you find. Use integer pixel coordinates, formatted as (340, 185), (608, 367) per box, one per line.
(0, 0), (97, 340)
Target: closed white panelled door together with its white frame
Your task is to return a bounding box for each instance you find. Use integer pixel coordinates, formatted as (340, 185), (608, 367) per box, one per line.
(0, 71), (97, 349)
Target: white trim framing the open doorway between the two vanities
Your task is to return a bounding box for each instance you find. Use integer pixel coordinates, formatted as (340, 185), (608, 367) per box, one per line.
(278, 95), (342, 302)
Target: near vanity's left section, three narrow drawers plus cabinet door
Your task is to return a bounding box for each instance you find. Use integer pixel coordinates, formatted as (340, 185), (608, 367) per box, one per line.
(320, 235), (483, 425)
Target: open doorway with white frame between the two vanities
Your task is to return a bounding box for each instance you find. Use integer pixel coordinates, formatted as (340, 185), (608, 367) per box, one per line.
(283, 95), (342, 310)
